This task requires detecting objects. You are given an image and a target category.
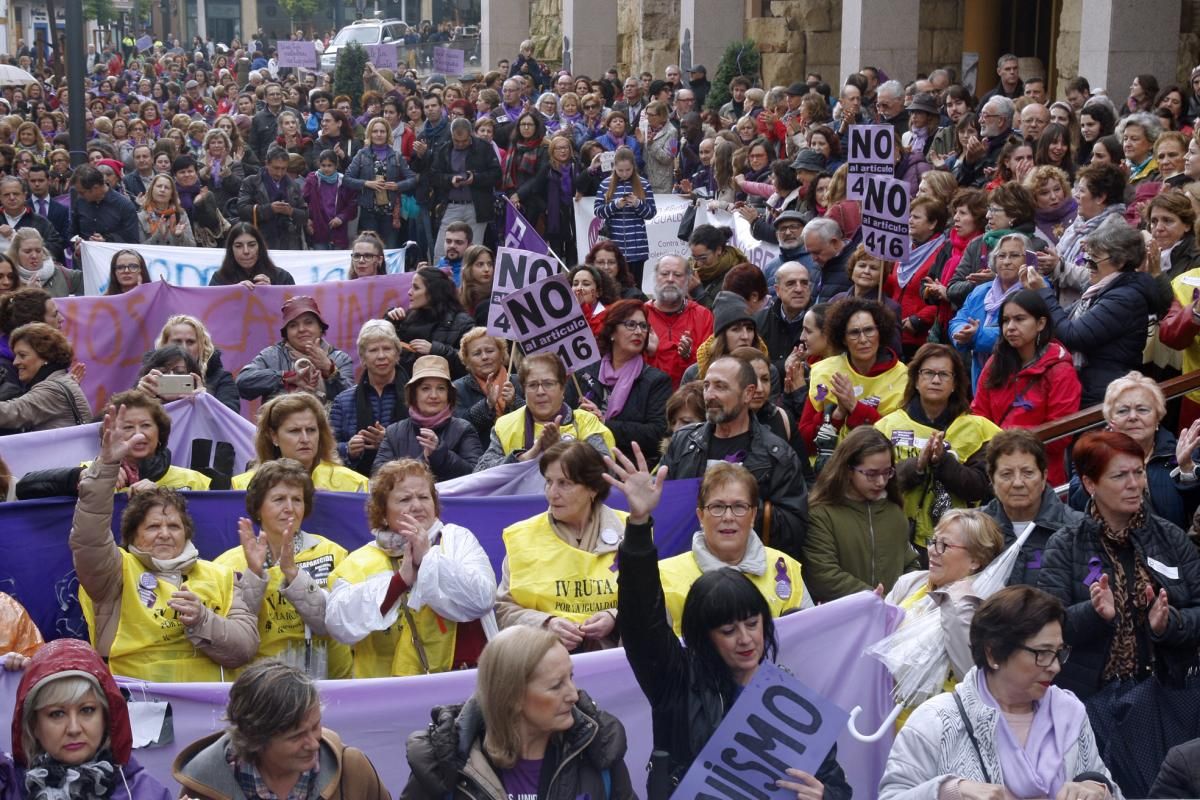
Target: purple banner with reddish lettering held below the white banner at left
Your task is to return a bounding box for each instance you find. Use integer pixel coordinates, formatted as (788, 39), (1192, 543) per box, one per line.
(58, 273), (413, 410)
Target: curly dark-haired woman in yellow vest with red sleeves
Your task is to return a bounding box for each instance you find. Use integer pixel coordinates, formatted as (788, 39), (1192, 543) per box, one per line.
(799, 297), (907, 463)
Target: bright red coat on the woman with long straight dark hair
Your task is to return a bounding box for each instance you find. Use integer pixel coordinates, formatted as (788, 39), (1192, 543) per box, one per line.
(971, 342), (1082, 486)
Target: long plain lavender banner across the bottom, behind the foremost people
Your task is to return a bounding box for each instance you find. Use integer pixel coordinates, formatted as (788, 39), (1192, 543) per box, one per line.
(0, 591), (900, 798)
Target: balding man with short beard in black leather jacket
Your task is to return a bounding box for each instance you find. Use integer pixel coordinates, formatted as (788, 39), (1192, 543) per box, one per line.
(660, 356), (808, 559)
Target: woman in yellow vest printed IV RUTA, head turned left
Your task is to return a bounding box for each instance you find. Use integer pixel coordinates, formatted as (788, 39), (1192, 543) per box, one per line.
(496, 441), (629, 651)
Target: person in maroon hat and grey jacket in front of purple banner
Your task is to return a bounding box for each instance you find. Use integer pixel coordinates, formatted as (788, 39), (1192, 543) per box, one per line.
(238, 295), (354, 402)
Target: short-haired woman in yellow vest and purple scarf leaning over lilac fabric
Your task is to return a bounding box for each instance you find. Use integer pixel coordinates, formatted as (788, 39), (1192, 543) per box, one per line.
(475, 353), (617, 473)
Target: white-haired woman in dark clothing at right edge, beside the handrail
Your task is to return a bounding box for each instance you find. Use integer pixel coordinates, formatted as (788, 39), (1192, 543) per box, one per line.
(1069, 372), (1200, 530)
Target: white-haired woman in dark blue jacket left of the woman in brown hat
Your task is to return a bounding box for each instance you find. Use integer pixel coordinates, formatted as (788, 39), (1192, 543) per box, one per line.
(329, 319), (409, 476)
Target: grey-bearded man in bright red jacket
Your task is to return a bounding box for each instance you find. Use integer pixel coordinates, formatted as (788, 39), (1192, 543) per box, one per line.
(646, 255), (713, 389)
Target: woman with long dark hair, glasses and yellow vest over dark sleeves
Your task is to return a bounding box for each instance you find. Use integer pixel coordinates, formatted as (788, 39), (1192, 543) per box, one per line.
(875, 344), (1000, 559)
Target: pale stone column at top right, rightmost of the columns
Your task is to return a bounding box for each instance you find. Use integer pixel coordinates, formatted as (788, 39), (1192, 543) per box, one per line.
(1079, 0), (1182, 98)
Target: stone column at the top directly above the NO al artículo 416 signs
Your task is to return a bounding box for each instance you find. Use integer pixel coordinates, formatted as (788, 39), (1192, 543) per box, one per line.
(844, 0), (920, 86)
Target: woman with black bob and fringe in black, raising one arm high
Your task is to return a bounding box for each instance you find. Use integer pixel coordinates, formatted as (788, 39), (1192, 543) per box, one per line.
(605, 444), (852, 800)
